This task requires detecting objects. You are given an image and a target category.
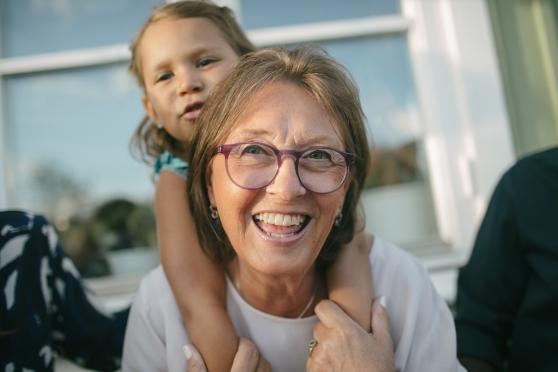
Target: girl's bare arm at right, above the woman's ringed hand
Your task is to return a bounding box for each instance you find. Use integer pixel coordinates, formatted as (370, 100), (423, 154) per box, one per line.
(327, 231), (374, 332)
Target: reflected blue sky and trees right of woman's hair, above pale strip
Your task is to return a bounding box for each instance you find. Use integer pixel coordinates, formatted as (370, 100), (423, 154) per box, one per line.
(322, 35), (424, 187)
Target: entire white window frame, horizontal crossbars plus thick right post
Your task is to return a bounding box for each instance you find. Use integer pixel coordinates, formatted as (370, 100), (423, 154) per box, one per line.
(0, 0), (514, 300)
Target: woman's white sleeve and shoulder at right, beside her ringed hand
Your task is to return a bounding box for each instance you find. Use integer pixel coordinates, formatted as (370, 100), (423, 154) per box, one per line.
(370, 237), (462, 371)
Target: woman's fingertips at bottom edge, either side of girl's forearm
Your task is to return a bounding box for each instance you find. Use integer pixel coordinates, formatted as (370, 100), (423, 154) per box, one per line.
(184, 338), (271, 372)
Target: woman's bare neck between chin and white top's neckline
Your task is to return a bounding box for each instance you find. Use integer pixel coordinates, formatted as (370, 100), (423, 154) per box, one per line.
(228, 259), (327, 318)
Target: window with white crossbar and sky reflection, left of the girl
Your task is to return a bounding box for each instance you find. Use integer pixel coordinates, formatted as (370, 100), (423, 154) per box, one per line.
(0, 0), (163, 276)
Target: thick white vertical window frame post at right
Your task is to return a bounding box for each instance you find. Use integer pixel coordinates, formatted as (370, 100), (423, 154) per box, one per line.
(402, 0), (514, 256)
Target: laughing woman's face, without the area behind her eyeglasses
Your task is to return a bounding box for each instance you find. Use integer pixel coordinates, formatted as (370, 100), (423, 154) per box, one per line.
(209, 82), (347, 275)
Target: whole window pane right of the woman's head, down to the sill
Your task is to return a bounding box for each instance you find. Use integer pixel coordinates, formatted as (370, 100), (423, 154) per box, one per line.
(321, 35), (437, 246)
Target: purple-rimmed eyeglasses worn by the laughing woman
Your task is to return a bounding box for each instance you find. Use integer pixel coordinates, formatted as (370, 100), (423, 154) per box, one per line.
(216, 142), (353, 194)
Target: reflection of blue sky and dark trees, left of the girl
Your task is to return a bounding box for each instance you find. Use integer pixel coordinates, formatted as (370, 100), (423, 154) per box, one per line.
(5, 64), (156, 276)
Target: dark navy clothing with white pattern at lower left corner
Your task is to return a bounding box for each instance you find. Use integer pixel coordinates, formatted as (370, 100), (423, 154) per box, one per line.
(0, 211), (129, 372)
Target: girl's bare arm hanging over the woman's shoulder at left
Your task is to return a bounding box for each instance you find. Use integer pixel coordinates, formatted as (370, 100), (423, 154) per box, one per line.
(155, 171), (238, 371)
